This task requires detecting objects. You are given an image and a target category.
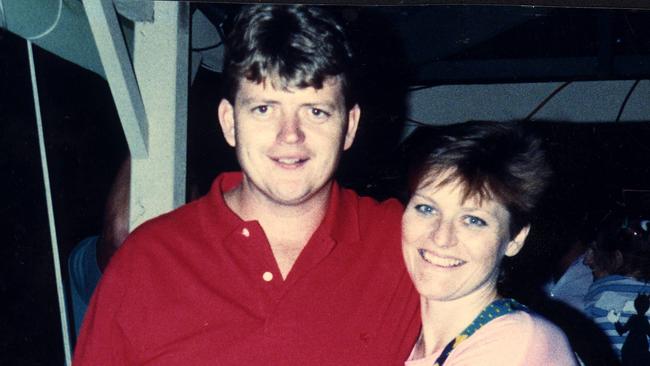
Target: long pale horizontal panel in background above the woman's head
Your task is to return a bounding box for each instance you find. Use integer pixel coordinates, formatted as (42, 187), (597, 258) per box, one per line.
(408, 80), (650, 125)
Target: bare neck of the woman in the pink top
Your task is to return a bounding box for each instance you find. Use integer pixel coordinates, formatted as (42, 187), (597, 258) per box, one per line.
(415, 289), (498, 358)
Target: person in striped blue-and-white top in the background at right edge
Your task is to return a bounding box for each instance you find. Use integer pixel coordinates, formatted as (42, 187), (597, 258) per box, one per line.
(585, 217), (650, 366)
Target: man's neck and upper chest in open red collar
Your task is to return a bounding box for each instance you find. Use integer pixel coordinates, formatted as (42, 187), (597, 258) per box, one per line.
(224, 183), (331, 278)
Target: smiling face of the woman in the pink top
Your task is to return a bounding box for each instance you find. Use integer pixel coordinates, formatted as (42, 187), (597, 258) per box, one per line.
(402, 174), (528, 301)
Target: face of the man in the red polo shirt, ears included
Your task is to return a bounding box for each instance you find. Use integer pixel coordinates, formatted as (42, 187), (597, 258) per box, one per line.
(219, 78), (360, 205)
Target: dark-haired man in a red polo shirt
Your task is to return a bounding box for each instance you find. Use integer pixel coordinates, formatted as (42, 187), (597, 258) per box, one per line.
(74, 5), (419, 365)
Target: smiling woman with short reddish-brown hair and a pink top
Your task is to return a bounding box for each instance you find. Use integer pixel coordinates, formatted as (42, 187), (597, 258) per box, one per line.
(402, 122), (576, 366)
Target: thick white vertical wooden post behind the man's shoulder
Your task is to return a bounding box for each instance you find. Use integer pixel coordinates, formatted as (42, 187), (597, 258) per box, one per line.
(129, 1), (189, 229)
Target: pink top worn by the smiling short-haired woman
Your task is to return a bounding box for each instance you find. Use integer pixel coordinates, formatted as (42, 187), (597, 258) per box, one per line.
(404, 311), (577, 366)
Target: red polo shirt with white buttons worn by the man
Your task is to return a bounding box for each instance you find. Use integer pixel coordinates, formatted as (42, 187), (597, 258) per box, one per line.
(74, 173), (420, 366)
